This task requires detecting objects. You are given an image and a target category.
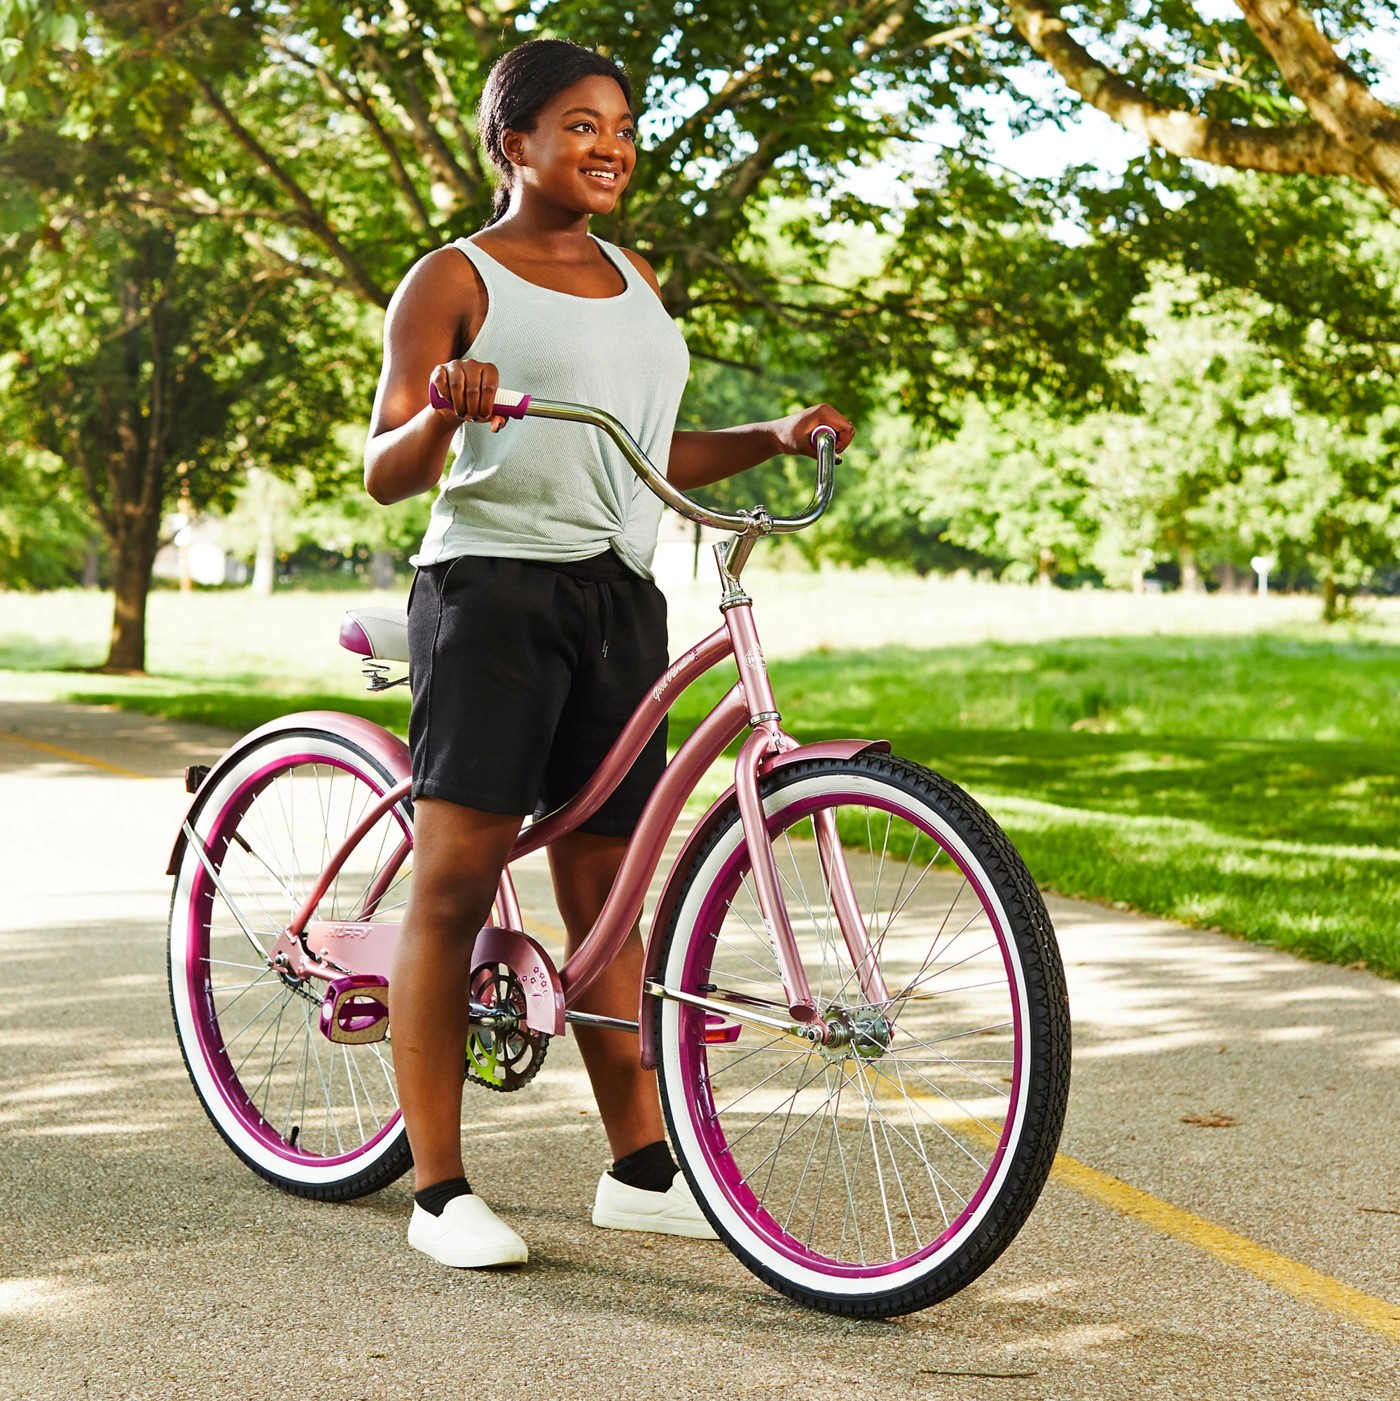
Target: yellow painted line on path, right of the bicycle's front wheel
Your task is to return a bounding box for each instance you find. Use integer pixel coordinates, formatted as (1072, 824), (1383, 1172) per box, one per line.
(1051, 1153), (1400, 1342)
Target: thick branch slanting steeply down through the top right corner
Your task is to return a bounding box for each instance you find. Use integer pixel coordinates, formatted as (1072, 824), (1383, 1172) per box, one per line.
(1235, 0), (1400, 205)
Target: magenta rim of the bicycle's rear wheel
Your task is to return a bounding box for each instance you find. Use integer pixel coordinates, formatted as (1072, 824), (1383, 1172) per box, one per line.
(185, 754), (401, 1167)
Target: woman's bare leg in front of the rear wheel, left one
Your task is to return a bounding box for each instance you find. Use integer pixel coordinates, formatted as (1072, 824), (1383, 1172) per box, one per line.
(390, 797), (526, 1191)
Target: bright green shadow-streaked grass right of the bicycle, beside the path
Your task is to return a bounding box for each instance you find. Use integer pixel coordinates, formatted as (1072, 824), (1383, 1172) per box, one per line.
(667, 636), (1400, 976)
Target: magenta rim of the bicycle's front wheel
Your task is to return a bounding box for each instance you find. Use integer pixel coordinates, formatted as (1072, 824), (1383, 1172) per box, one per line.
(677, 792), (1024, 1279)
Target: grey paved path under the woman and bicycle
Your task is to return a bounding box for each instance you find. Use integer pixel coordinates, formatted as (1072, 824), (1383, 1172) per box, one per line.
(0, 703), (1400, 1401)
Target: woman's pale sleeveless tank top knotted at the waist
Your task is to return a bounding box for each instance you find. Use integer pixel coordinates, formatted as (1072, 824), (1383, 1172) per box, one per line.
(413, 235), (689, 579)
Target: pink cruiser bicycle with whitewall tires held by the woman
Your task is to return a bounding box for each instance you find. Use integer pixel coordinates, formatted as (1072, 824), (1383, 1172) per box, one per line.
(170, 394), (1069, 1317)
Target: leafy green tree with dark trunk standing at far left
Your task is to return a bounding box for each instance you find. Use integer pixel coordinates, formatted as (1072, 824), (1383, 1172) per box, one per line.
(0, 17), (369, 670)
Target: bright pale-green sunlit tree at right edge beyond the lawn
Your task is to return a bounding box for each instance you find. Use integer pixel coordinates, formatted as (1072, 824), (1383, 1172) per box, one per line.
(917, 280), (1400, 608)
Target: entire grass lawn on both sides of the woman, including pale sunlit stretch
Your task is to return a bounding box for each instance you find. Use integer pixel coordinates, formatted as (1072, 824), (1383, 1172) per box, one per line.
(0, 576), (1400, 976)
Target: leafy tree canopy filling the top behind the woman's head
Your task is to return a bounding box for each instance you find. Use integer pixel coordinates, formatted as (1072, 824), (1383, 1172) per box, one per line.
(0, 0), (1400, 658)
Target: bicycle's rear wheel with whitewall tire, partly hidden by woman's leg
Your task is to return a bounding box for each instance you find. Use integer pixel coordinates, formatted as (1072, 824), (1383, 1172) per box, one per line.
(168, 729), (412, 1201)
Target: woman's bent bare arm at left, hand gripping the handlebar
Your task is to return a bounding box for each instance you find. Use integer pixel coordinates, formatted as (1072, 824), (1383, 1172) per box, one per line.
(364, 248), (506, 506)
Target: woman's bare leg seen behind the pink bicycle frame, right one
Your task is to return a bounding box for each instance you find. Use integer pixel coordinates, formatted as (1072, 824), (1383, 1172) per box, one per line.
(543, 832), (666, 1161)
